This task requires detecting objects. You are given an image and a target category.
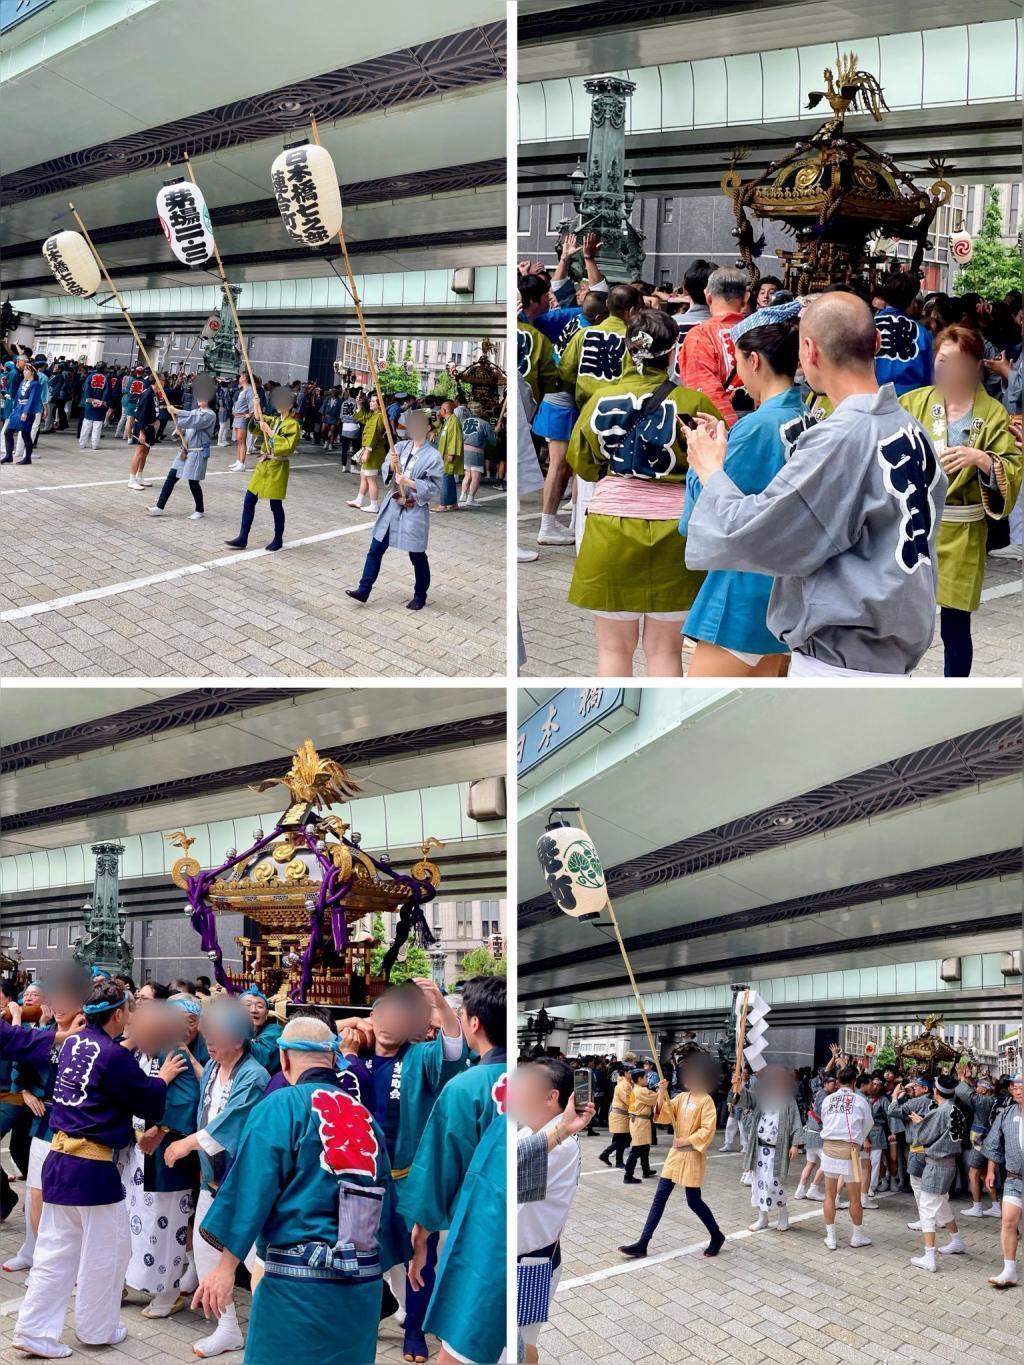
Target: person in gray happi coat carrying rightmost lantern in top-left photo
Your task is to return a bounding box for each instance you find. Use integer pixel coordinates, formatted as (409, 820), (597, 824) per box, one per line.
(345, 408), (444, 612)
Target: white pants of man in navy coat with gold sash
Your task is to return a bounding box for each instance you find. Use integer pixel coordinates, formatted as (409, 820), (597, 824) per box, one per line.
(14, 1201), (131, 1346)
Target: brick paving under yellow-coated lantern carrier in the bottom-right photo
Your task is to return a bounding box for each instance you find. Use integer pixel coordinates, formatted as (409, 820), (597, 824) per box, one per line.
(539, 1133), (1021, 1365)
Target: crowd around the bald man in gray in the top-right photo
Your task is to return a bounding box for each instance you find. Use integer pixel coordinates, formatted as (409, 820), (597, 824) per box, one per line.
(517, 236), (1024, 677)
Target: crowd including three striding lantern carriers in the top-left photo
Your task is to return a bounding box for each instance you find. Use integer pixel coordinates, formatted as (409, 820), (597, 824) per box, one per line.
(0, 346), (505, 612)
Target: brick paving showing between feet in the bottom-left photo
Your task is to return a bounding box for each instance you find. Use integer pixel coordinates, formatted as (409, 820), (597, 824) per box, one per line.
(0, 1190), (409, 1365)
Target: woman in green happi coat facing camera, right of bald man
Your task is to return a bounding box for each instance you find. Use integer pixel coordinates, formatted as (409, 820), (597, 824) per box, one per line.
(900, 325), (1021, 677)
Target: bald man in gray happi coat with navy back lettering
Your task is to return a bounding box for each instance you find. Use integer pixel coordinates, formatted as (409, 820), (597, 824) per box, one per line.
(685, 293), (946, 677)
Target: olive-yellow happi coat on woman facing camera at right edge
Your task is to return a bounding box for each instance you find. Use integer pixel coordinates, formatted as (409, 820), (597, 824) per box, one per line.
(900, 384), (1021, 612)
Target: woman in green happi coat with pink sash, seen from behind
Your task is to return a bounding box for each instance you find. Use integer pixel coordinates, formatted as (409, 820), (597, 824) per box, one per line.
(567, 310), (721, 677)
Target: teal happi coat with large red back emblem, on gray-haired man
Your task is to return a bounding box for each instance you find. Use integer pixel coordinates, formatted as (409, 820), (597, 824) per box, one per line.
(198, 1067), (393, 1365)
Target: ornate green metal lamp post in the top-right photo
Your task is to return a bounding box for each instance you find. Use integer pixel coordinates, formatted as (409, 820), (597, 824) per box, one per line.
(558, 76), (644, 284)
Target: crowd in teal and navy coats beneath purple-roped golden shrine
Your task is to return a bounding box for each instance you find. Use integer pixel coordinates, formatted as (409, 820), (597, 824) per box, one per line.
(0, 964), (507, 1365)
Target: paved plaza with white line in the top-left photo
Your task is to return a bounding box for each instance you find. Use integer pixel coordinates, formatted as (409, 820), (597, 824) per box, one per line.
(0, 431), (505, 678)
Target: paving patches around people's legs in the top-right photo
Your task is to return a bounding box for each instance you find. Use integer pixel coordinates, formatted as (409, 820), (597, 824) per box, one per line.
(519, 494), (1024, 678)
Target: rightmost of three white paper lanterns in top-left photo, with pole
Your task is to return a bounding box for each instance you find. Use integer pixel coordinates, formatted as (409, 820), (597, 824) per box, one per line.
(270, 116), (399, 472)
